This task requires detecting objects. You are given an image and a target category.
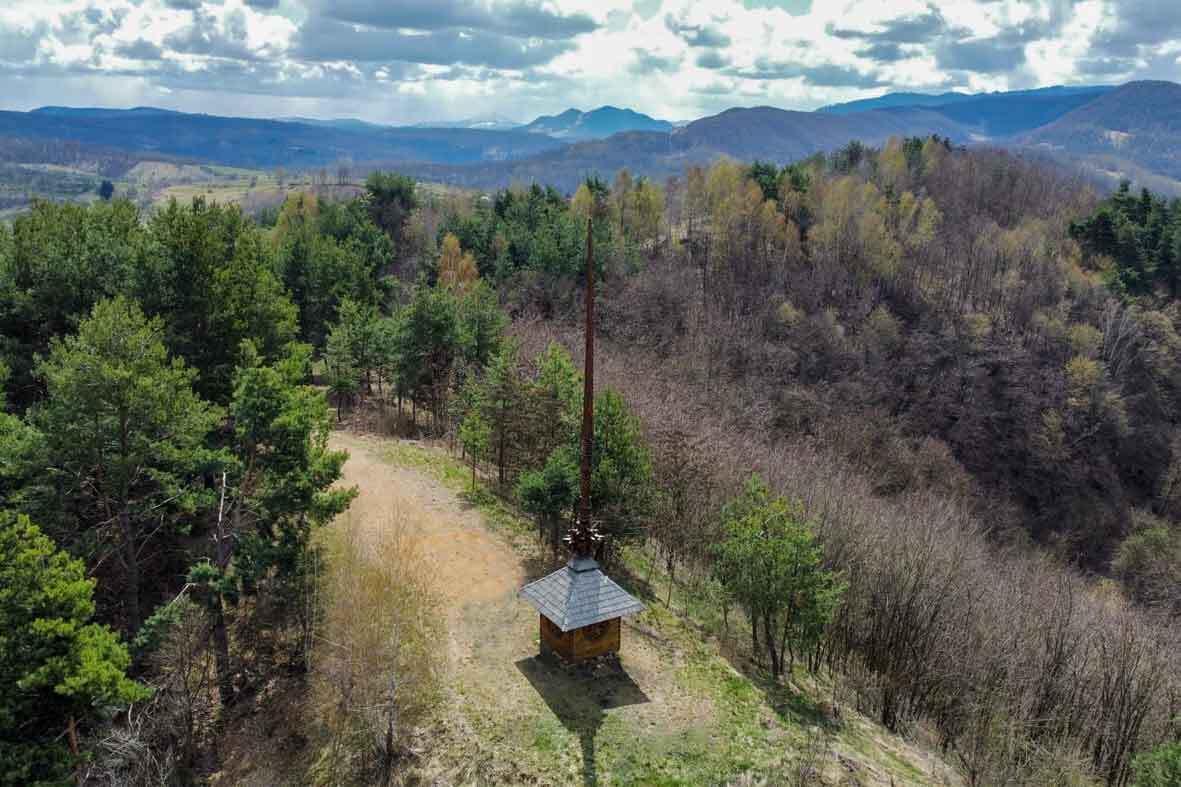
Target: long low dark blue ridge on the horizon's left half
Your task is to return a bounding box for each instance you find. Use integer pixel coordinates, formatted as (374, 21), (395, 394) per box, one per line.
(0, 108), (561, 168)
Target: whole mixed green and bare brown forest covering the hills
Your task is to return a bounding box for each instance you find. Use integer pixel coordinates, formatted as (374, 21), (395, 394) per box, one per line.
(0, 137), (1181, 786)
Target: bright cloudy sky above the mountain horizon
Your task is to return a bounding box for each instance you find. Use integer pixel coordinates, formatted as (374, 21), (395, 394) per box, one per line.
(0, 0), (1181, 123)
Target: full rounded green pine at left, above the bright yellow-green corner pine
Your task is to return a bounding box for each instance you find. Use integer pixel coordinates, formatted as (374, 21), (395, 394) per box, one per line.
(33, 298), (218, 631)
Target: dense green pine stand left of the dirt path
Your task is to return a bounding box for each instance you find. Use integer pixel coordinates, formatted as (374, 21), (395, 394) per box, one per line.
(0, 175), (441, 785)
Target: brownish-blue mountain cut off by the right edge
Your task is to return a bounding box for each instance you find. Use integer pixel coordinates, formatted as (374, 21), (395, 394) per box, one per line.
(1017, 82), (1181, 180)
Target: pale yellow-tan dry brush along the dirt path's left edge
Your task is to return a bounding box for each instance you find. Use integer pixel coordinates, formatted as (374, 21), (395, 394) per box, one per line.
(308, 501), (445, 785)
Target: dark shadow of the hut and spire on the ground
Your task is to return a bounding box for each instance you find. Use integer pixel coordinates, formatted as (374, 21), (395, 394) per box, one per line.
(516, 656), (651, 787)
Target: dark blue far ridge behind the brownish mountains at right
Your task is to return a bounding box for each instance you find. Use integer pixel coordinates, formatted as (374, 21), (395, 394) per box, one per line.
(817, 85), (1113, 138)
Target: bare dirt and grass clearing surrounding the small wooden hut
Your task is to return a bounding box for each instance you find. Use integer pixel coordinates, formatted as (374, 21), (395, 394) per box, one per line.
(316, 432), (957, 785)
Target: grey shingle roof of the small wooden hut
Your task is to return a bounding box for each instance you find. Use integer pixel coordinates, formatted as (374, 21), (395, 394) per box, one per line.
(521, 550), (644, 631)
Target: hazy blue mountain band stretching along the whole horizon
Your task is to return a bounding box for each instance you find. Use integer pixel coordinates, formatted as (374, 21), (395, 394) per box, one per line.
(0, 82), (1181, 190)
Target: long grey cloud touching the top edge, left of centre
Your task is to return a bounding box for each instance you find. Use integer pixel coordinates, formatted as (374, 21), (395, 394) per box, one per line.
(313, 0), (599, 40)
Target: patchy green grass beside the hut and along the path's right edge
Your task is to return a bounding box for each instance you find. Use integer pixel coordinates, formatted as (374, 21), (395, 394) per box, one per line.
(361, 441), (958, 786)
